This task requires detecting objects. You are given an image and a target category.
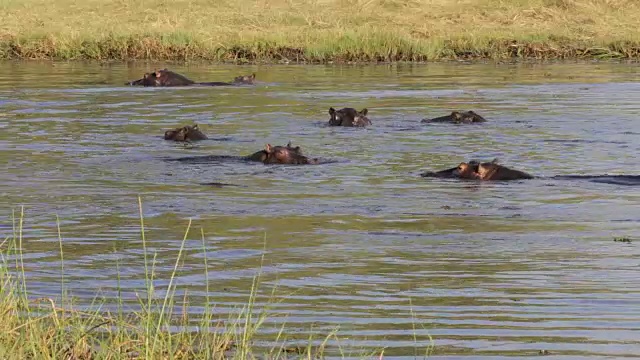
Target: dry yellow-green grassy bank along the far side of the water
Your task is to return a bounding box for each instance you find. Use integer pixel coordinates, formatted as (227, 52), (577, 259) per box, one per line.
(0, 0), (640, 63)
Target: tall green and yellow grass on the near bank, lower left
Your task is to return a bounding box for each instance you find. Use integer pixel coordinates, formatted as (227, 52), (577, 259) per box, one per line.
(0, 203), (433, 360)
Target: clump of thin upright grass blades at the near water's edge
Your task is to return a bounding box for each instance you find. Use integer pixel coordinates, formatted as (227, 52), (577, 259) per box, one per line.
(0, 203), (434, 360)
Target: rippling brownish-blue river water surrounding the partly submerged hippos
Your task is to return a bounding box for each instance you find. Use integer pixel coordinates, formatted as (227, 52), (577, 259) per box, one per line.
(0, 63), (640, 359)
